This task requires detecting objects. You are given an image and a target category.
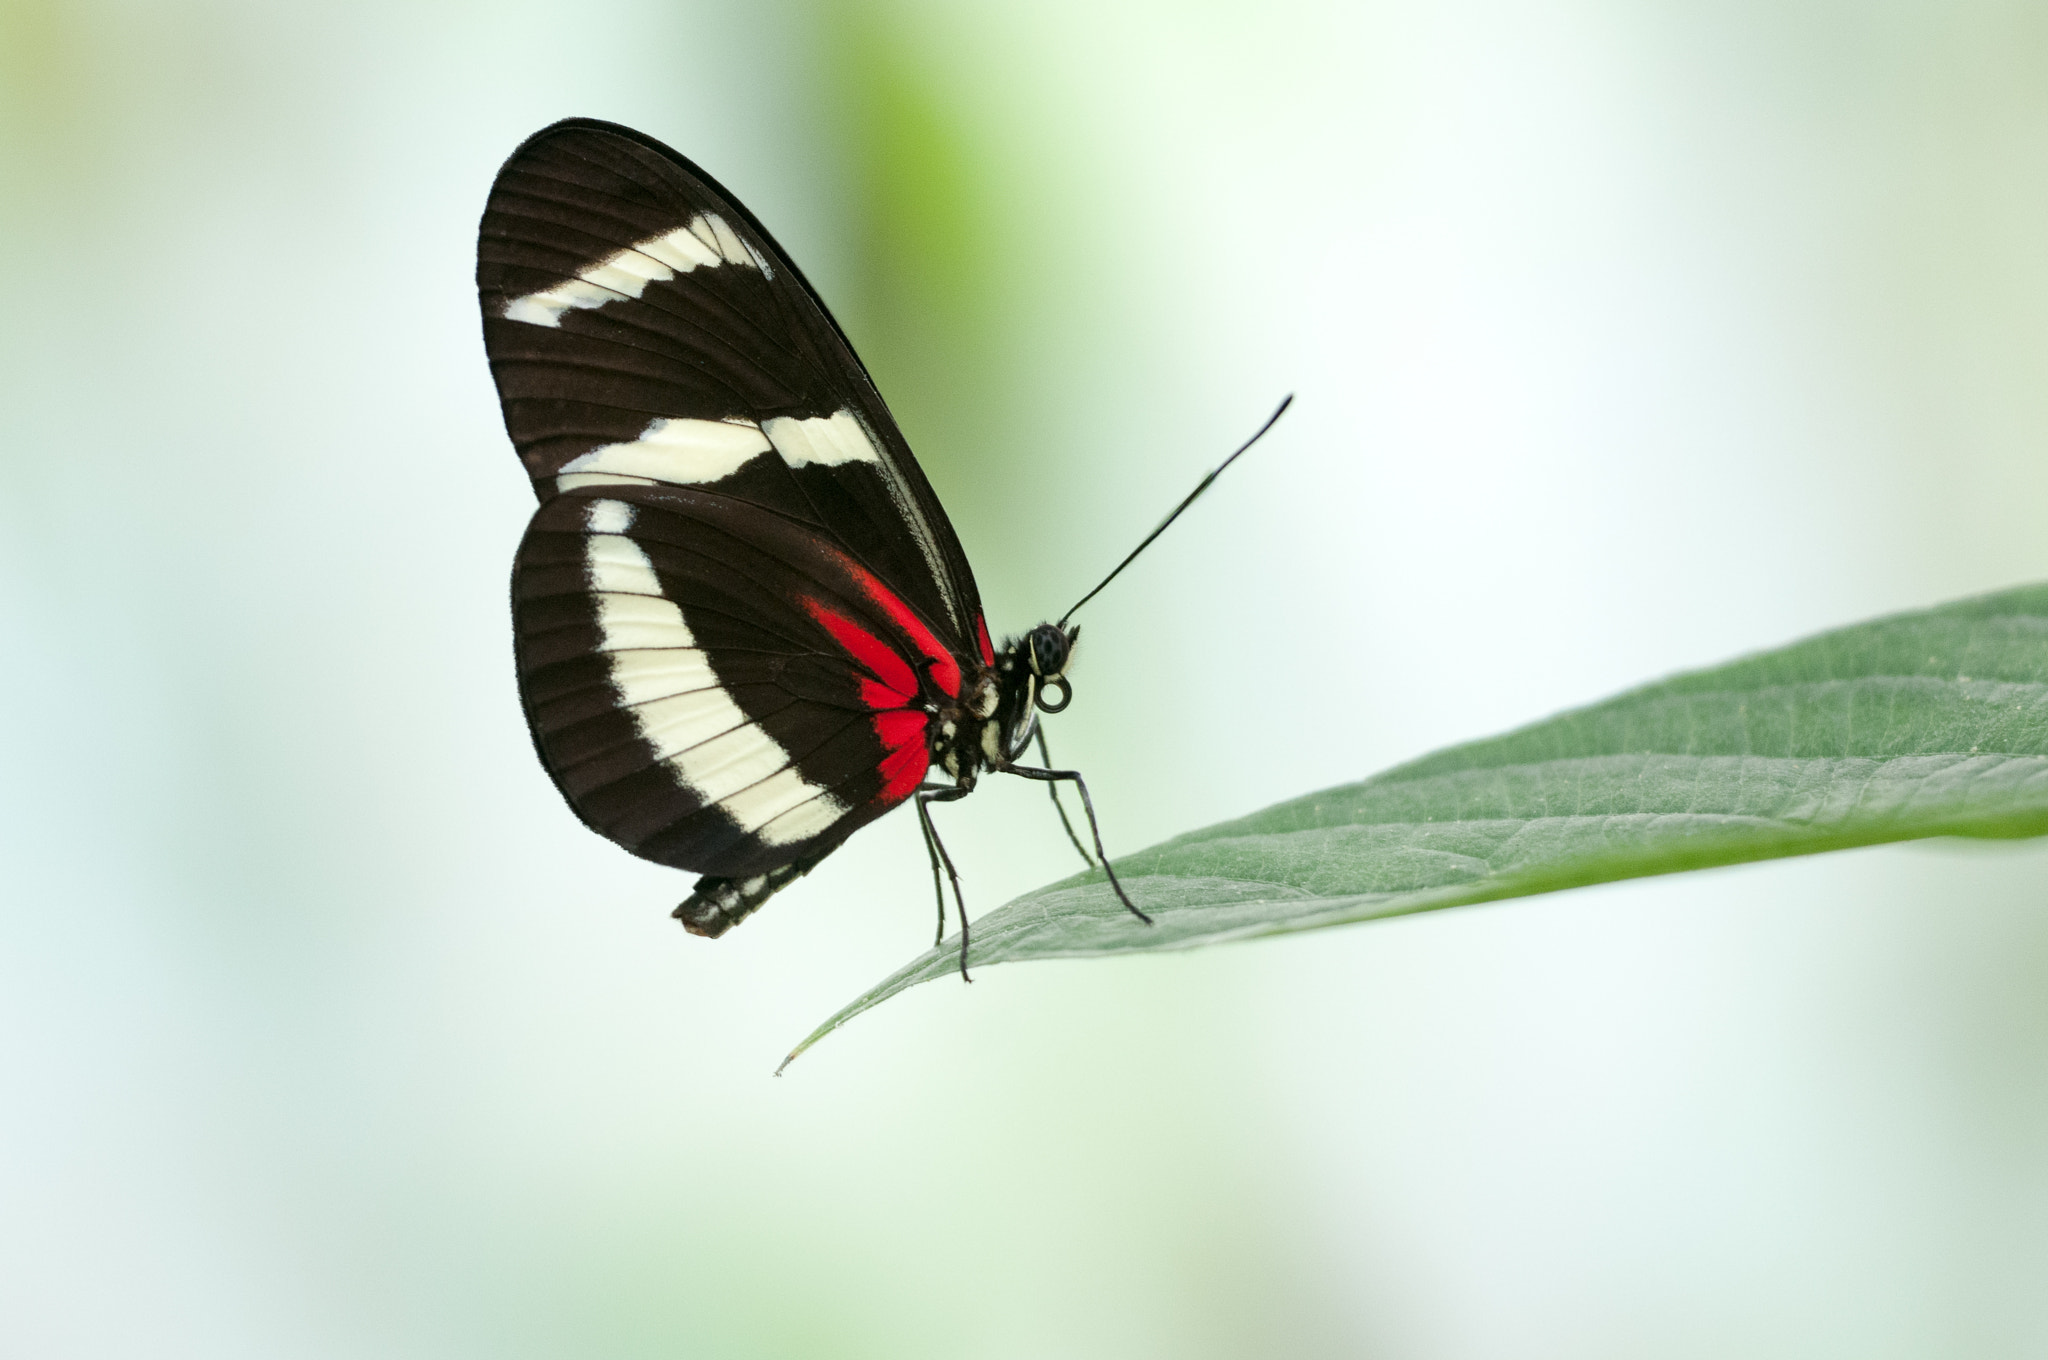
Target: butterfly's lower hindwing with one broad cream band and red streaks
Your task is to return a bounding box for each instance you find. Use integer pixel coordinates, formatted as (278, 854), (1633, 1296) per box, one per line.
(512, 485), (961, 877)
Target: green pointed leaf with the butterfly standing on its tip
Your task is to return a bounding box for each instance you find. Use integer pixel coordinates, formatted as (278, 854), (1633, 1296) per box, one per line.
(784, 586), (2048, 1065)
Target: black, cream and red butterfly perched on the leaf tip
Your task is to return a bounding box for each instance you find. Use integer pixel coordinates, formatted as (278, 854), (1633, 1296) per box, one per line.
(477, 119), (1286, 975)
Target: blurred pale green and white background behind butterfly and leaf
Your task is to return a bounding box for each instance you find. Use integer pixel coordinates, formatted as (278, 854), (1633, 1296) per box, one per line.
(0, 0), (2048, 1360)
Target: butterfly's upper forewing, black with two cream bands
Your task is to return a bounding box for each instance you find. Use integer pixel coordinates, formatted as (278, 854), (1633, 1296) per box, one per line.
(477, 119), (981, 655)
